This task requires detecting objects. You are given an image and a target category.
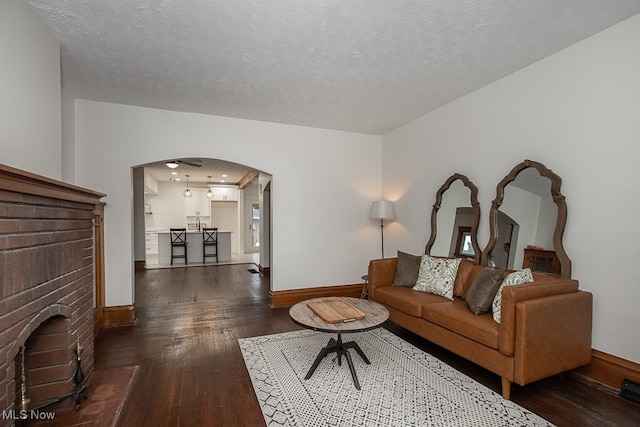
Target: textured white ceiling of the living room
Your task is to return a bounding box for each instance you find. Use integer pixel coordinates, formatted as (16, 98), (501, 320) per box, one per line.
(25, 0), (640, 134)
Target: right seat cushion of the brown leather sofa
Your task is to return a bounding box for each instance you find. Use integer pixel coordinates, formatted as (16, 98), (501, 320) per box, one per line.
(422, 298), (500, 349)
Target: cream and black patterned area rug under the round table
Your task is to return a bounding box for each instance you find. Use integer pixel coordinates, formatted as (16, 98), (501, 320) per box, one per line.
(239, 329), (550, 427)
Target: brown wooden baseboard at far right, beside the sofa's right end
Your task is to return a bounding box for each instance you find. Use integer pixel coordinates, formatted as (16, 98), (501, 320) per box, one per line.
(574, 349), (640, 390)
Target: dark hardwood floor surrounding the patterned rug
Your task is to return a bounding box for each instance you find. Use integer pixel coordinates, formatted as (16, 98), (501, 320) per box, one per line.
(95, 264), (640, 427)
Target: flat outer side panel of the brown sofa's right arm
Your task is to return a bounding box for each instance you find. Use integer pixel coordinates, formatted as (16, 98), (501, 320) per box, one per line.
(514, 291), (593, 385)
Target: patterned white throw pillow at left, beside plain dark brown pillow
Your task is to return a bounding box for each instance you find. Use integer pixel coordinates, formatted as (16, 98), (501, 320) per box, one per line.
(413, 255), (460, 300)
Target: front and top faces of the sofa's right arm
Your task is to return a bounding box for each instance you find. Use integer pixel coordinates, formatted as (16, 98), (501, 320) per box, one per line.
(500, 279), (578, 357)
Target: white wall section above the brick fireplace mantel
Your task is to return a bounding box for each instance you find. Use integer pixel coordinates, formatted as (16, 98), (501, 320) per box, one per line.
(0, 0), (62, 179)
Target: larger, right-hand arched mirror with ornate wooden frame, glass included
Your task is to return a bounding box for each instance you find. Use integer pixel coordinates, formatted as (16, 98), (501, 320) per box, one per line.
(481, 160), (571, 278)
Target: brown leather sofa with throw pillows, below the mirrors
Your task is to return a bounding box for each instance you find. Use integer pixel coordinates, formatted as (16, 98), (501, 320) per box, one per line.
(368, 258), (593, 400)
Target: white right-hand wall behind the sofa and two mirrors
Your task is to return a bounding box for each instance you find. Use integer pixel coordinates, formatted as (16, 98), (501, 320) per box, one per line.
(382, 15), (640, 362)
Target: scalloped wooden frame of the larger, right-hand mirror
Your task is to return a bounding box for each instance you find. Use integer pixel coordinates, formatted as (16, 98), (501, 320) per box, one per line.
(481, 160), (571, 279)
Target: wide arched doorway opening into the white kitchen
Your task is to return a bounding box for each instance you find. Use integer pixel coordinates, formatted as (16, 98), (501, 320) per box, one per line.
(132, 158), (271, 269)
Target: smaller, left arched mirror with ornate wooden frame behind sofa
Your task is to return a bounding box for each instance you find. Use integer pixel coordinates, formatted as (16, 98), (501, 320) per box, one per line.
(425, 173), (480, 262)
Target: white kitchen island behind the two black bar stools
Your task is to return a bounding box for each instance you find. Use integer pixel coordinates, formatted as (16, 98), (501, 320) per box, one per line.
(158, 230), (233, 265)
